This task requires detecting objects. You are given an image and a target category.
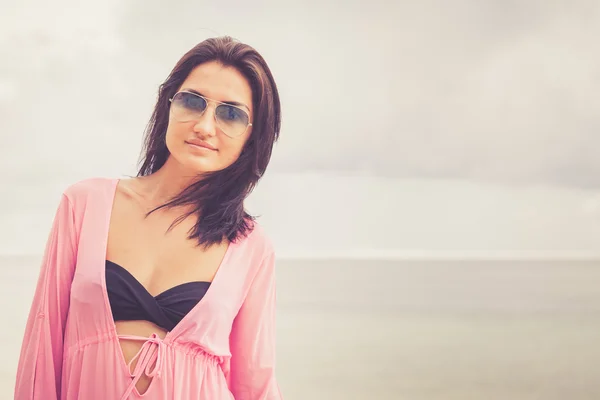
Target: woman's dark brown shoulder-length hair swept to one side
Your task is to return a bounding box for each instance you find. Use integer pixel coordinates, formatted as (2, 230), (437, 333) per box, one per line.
(138, 36), (281, 246)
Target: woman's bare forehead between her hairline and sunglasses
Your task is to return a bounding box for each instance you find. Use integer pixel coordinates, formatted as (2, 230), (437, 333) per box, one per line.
(180, 61), (252, 112)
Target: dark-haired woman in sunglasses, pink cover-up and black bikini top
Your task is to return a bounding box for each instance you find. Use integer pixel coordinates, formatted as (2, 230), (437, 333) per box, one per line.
(15, 37), (281, 400)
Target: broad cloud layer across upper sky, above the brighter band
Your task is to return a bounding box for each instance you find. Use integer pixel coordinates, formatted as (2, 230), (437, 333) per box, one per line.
(0, 0), (600, 187)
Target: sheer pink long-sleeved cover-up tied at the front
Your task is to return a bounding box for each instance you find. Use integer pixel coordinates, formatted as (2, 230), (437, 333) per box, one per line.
(15, 178), (282, 400)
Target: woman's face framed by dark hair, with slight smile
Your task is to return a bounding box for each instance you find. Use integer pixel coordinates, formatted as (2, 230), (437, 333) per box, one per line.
(166, 61), (254, 174)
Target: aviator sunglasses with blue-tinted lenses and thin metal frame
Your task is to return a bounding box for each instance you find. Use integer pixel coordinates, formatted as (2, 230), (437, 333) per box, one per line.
(169, 91), (252, 138)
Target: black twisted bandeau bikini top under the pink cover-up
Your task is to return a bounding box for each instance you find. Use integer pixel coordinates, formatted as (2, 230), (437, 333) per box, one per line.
(106, 260), (210, 331)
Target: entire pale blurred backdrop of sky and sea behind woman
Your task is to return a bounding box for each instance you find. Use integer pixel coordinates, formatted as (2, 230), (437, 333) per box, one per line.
(0, 0), (600, 400)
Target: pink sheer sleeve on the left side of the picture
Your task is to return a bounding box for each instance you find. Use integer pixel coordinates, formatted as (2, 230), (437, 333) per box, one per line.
(15, 194), (77, 400)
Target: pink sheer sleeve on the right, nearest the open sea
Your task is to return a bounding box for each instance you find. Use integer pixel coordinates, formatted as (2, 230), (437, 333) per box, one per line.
(230, 253), (282, 400)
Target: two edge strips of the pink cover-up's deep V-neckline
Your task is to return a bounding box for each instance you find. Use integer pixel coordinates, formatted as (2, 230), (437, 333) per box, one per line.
(99, 178), (238, 343)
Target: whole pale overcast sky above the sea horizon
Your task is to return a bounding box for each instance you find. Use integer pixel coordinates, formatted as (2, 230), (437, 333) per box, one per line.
(0, 0), (600, 255)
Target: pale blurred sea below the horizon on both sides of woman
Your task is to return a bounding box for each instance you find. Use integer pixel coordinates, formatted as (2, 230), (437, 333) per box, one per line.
(0, 256), (600, 400)
